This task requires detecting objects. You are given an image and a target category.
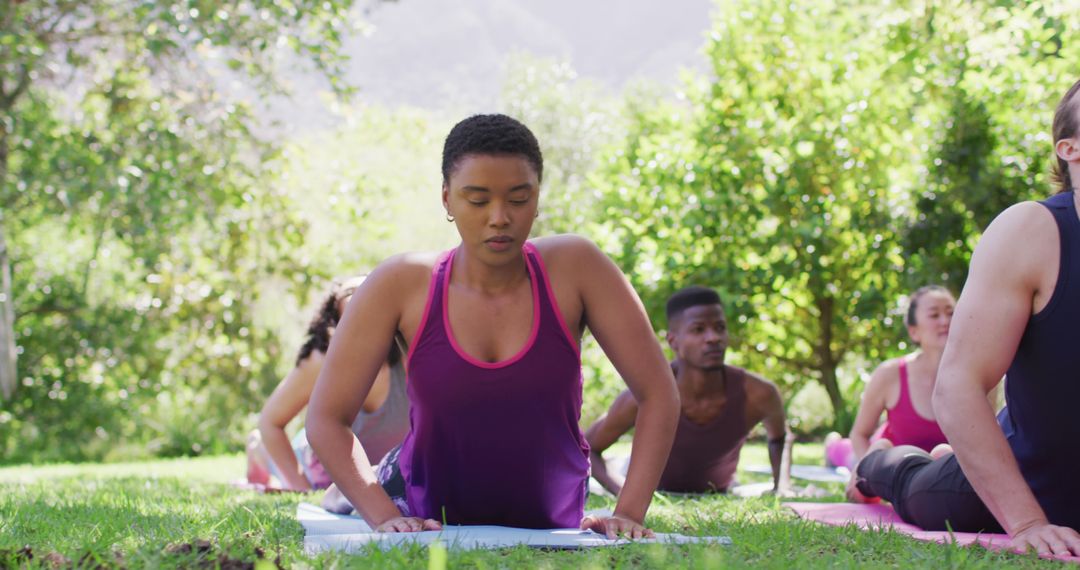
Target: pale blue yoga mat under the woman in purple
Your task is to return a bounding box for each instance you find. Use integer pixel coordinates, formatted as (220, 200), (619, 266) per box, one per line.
(296, 503), (731, 554)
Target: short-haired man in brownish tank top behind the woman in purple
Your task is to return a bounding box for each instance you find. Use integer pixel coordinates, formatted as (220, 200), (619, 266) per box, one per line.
(585, 287), (792, 496)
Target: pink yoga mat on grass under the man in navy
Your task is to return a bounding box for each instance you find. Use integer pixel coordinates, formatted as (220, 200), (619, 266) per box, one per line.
(784, 503), (1080, 564)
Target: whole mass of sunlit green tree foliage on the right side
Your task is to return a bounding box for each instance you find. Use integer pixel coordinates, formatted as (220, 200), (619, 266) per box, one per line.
(597, 0), (1075, 429)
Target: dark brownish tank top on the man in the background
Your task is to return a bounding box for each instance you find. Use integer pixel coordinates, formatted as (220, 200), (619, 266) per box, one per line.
(658, 365), (748, 492)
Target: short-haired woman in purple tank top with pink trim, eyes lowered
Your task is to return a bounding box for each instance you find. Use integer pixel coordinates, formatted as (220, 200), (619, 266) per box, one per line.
(308, 116), (679, 538)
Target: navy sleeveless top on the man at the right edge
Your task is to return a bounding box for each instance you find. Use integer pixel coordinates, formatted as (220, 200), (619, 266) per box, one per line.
(998, 192), (1080, 530)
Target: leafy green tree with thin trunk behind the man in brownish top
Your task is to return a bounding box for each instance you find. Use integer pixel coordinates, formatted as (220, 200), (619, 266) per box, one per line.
(596, 0), (933, 428)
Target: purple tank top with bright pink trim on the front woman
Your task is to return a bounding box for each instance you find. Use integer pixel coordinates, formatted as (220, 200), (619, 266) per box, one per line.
(400, 243), (589, 528)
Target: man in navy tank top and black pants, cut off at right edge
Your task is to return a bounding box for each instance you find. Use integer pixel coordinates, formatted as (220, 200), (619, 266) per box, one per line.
(856, 81), (1080, 555)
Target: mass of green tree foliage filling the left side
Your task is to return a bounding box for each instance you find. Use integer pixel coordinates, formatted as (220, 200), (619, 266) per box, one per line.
(0, 0), (373, 461)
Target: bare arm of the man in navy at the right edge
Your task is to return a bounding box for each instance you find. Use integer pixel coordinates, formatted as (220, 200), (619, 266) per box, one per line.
(933, 203), (1080, 554)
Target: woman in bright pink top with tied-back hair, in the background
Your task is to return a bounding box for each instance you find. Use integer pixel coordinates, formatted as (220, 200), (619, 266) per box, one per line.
(825, 285), (956, 469)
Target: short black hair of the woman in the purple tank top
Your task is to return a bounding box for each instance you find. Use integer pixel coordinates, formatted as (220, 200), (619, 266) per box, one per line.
(443, 114), (543, 184)
